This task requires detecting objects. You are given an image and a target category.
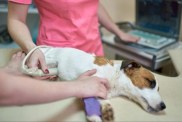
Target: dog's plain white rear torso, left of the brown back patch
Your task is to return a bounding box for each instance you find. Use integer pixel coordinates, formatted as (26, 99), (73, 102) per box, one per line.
(42, 48), (95, 80)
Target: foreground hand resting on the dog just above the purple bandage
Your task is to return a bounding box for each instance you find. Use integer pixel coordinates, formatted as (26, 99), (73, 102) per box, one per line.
(77, 69), (109, 98)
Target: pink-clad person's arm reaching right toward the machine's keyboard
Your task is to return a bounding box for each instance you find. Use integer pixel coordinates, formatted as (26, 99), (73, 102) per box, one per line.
(98, 3), (139, 42)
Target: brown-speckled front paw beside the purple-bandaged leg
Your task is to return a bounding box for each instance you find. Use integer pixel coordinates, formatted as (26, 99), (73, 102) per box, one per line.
(101, 103), (114, 122)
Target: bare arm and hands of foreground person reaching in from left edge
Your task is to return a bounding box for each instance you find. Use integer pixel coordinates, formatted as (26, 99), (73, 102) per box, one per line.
(0, 52), (108, 106)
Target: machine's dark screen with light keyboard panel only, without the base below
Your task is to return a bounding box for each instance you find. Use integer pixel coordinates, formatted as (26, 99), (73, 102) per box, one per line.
(125, 0), (182, 50)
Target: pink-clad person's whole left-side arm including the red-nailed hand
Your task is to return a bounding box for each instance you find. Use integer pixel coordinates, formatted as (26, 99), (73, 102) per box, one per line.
(8, 1), (48, 73)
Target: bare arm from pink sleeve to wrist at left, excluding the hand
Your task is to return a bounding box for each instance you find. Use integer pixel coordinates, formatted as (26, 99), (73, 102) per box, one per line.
(8, 2), (35, 53)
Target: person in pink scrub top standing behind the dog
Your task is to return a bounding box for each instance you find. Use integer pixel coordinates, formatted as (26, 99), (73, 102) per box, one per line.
(8, 0), (138, 73)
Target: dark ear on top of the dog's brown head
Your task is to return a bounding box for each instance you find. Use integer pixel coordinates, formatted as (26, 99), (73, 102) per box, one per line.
(120, 60), (141, 69)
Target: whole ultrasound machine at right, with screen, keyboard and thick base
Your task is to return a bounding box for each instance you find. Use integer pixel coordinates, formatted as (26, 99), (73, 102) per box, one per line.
(109, 0), (182, 70)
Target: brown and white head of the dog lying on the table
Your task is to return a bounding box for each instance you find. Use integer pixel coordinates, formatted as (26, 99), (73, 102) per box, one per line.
(121, 61), (166, 112)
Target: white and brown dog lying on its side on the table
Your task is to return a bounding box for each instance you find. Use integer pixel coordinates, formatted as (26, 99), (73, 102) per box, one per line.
(22, 46), (166, 122)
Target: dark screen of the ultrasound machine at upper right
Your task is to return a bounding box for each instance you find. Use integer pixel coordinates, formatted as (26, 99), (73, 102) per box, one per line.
(136, 0), (181, 37)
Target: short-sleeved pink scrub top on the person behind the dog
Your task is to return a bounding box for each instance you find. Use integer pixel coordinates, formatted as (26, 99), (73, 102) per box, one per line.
(9, 0), (104, 56)
